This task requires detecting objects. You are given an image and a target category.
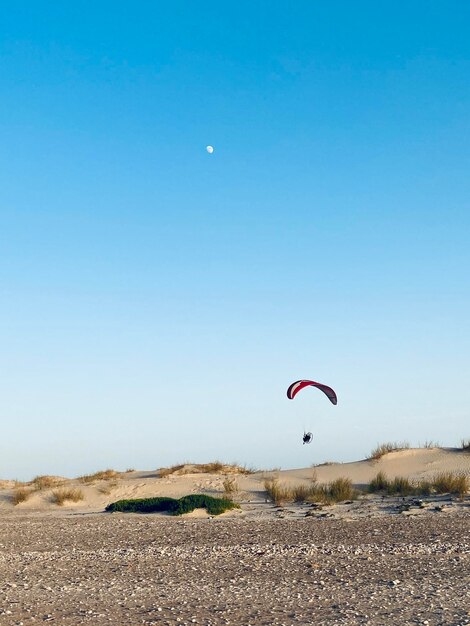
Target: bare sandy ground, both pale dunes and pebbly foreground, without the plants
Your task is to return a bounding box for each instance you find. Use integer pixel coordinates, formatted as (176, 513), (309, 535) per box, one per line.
(0, 449), (470, 626)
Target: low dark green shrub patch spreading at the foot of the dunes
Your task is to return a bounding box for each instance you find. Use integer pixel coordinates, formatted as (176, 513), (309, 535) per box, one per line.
(106, 494), (240, 515)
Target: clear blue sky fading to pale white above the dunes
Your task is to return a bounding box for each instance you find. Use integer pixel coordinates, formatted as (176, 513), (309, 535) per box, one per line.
(0, 0), (470, 478)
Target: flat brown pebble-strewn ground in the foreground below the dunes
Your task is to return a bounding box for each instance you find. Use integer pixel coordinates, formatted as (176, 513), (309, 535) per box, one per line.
(0, 512), (470, 626)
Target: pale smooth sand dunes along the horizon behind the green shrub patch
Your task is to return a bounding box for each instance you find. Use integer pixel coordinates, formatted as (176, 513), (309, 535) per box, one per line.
(0, 448), (470, 515)
